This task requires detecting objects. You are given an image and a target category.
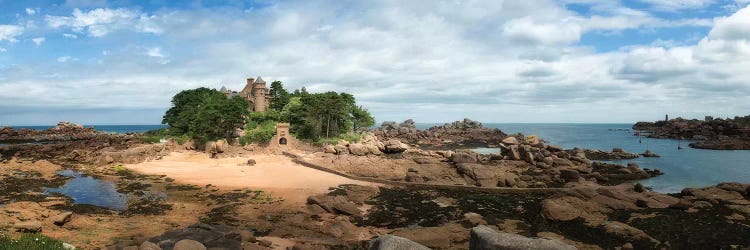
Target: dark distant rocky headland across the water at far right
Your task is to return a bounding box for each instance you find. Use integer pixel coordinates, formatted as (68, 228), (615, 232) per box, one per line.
(633, 116), (750, 150)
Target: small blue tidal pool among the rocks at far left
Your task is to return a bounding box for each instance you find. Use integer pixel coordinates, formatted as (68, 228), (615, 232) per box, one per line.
(45, 170), (128, 211)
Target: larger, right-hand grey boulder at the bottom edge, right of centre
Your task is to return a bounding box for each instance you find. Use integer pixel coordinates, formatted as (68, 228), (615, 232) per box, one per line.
(469, 226), (576, 250)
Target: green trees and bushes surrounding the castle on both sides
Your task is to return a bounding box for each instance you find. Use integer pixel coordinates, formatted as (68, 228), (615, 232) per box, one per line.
(155, 81), (375, 145)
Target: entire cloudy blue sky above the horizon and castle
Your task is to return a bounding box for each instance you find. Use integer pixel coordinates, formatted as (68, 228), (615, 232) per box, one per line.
(0, 0), (750, 125)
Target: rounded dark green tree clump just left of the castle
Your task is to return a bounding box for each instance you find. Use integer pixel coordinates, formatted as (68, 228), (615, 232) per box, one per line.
(162, 88), (248, 141)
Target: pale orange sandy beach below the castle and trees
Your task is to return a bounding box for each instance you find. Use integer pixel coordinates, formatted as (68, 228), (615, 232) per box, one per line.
(125, 152), (382, 201)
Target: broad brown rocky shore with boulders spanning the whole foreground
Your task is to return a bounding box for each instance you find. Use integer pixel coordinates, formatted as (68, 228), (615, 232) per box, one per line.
(0, 120), (750, 249)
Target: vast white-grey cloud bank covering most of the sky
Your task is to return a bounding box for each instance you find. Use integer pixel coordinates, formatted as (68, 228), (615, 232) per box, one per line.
(0, 0), (750, 122)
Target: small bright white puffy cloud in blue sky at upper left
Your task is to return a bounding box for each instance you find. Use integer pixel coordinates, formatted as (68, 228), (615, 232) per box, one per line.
(45, 8), (160, 37)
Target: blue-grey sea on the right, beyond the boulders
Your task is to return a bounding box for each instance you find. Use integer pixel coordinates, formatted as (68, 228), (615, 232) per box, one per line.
(418, 124), (750, 193)
